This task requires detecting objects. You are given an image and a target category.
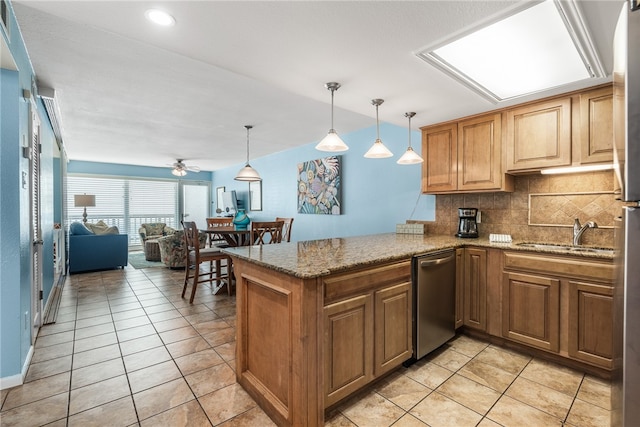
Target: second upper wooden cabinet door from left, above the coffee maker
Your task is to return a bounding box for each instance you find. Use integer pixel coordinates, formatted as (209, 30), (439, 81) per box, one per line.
(458, 113), (502, 191)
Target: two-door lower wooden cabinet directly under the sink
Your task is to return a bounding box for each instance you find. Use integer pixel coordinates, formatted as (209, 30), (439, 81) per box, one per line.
(502, 251), (614, 369)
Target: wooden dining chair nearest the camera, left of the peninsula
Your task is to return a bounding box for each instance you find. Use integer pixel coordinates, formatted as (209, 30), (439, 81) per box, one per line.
(182, 221), (232, 304)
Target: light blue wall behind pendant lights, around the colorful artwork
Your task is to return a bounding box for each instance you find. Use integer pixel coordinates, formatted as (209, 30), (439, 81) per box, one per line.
(213, 123), (435, 241)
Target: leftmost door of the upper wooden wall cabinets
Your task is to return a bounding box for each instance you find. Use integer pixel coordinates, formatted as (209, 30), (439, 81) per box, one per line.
(422, 123), (458, 193)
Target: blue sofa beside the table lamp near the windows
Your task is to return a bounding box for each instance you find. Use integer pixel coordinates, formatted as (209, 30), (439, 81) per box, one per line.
(69, 223), (129, 273)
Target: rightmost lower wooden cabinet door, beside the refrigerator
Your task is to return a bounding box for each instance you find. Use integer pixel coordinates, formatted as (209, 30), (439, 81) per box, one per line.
(569, 281), (613, 369)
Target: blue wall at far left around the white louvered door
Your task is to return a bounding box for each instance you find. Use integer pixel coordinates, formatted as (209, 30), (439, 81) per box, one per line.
(0, 3), (56, 388)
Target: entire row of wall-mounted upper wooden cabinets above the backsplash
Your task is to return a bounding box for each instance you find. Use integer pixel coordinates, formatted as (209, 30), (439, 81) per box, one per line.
(421, 84), (613, 184)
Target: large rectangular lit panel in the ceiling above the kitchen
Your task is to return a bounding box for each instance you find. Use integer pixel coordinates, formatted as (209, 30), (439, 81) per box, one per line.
(417, 0), (605, 102)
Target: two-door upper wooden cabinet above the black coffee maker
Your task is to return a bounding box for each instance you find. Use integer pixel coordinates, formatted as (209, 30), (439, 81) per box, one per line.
(422, 113), (513, 193)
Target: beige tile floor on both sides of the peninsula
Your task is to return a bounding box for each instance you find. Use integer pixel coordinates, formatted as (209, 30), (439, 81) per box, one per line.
(0, 267), (610, 427)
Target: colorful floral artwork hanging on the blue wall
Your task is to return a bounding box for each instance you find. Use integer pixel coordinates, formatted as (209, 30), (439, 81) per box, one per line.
(298, 156), (342, 215)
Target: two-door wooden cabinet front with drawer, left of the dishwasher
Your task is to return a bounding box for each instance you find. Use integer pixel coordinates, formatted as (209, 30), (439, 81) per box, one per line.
(324, 261), (413, 407)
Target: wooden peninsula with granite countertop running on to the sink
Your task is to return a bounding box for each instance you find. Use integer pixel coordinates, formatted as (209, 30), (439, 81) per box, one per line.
(224, 233), (612, 426)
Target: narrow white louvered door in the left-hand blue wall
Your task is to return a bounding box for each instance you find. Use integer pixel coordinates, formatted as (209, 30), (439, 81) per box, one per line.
(29, 107), (43, 344)
